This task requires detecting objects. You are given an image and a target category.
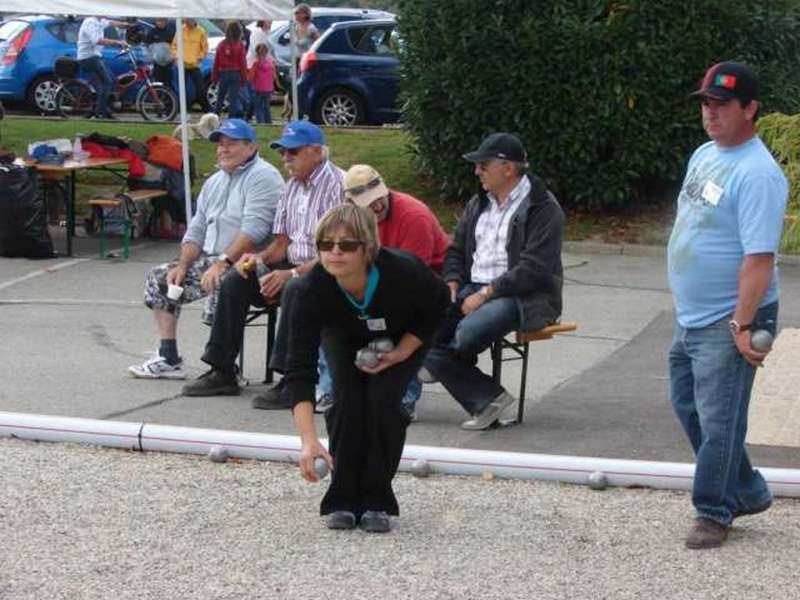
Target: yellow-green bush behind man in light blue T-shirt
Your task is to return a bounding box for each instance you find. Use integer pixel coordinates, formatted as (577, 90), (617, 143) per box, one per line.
(758, 113), (800, 252)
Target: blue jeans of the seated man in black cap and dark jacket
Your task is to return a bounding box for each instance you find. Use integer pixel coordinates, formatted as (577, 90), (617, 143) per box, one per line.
(425, 283), (520, 415)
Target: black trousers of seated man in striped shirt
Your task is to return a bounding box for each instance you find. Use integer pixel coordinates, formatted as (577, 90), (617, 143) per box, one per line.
(201, 263), (294, 375)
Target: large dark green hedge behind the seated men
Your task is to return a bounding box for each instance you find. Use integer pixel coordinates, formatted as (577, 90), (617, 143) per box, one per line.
(398, 0), (800, 208)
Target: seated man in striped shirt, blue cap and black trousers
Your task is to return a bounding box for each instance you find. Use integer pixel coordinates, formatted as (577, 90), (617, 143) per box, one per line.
(183, 121), (344, 398)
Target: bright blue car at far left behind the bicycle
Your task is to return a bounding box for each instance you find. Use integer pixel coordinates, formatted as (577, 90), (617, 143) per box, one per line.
(0, 16), (213, 114)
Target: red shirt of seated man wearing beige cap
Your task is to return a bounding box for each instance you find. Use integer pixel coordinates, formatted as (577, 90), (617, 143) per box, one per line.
(378, 190), (450, 273)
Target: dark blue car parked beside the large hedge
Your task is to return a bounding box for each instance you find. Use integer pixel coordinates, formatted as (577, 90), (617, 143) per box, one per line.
(297, 19), (401, 127)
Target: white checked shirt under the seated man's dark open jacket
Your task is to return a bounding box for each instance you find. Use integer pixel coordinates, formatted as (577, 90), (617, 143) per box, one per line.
(470, 176), (531, 283)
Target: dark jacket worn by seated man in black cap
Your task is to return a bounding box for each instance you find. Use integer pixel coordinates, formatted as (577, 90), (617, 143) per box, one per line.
(442, 174), (564, 331)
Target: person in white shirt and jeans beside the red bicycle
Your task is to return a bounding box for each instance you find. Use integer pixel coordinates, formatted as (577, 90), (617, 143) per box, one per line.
(77, 17), (130, 119)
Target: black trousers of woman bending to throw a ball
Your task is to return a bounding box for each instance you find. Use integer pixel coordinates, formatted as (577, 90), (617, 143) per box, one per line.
(320, 329), (427, 519)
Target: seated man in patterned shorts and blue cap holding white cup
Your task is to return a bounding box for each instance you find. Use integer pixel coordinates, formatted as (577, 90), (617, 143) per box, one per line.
(128, 119), (284, 382)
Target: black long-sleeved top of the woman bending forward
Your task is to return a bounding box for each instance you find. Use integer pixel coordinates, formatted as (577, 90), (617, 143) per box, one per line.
(284, 248), (450, 405)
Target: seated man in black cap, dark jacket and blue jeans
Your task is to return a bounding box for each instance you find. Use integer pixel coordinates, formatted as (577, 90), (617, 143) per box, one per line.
(422, 133), (564, 430)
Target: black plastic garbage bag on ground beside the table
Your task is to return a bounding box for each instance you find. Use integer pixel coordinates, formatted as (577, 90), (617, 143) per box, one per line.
(0, 165), (55, 258)
